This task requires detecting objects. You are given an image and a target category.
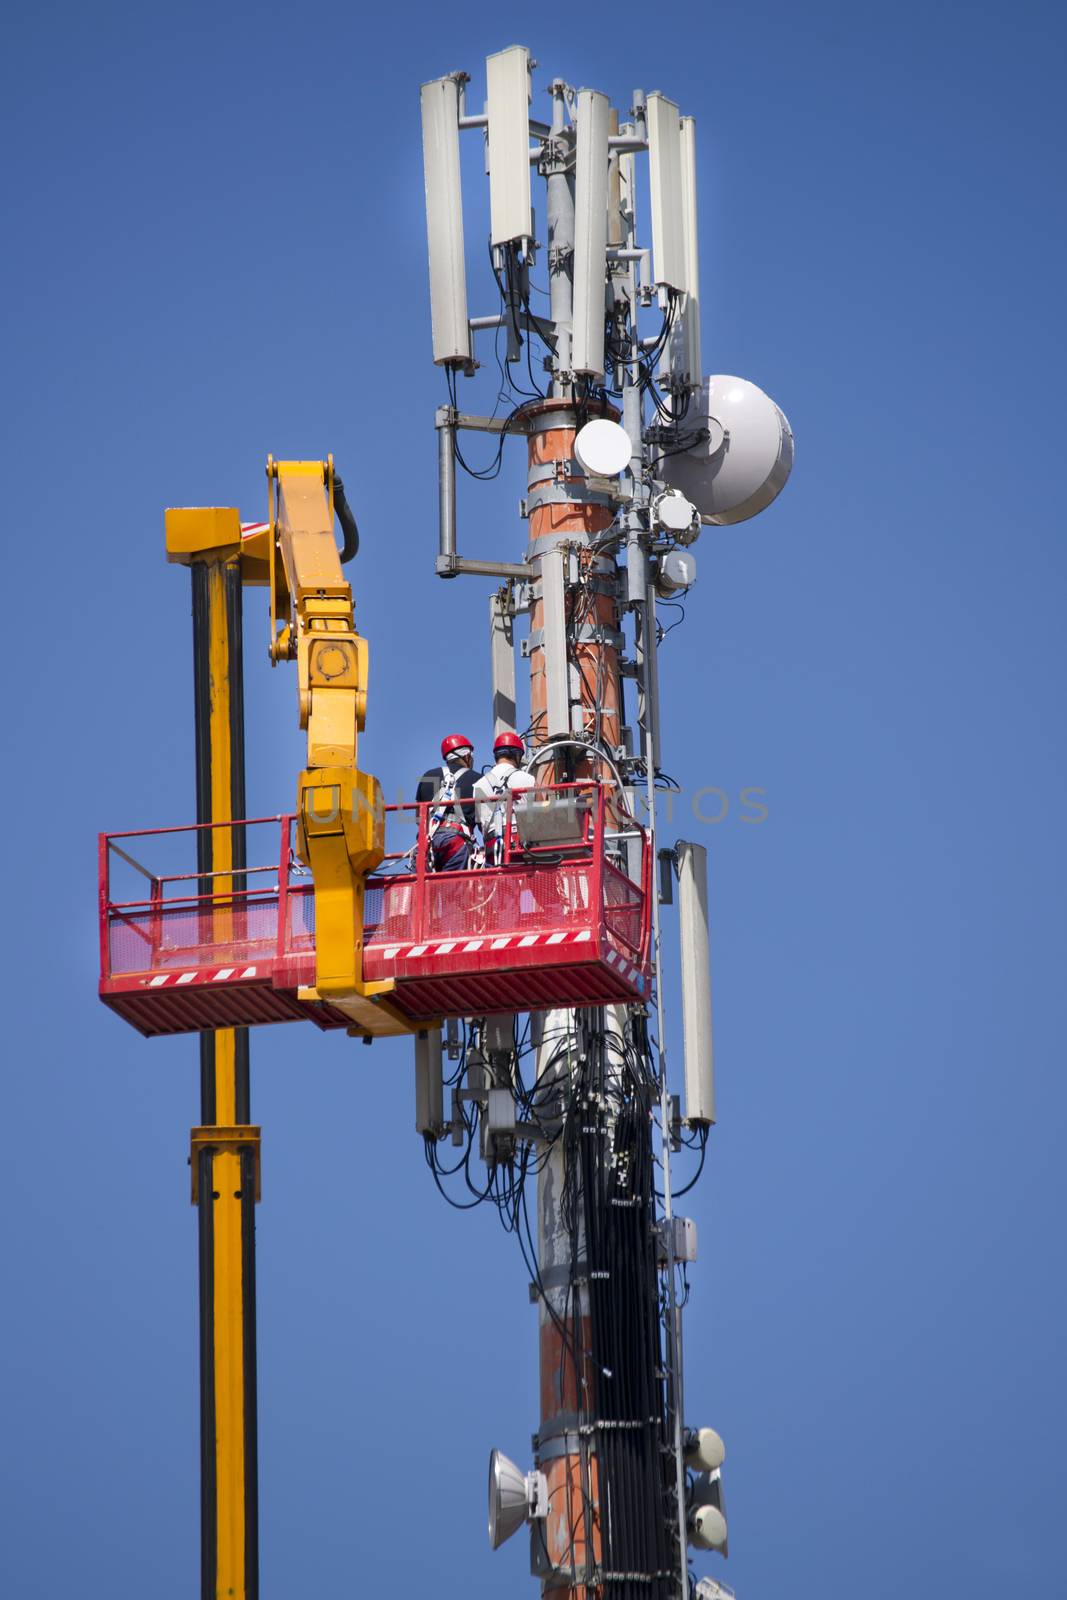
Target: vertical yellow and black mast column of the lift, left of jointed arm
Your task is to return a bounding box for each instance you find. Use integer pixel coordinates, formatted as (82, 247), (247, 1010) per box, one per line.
(166, 507), (259, 1600)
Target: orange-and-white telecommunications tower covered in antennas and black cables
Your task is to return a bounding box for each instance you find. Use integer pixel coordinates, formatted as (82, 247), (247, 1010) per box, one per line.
(416, 46), (793, 1600)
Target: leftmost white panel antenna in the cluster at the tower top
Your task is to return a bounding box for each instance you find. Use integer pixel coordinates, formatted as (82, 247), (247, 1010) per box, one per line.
(421, 75), (472, 366)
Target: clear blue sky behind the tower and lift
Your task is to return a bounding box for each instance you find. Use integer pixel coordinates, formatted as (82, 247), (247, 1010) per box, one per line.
(0, 0), (1067, 1600)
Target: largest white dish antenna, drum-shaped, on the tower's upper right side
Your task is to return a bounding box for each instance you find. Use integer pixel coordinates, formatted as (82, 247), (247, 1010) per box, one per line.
(662, 374), (793, 523)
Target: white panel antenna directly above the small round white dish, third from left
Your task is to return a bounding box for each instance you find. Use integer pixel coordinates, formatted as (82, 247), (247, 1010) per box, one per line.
(571, 90), (611, 378)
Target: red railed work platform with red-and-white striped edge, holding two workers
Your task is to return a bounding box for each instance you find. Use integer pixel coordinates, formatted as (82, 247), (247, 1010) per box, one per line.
(99, 784), (651, 1037)
